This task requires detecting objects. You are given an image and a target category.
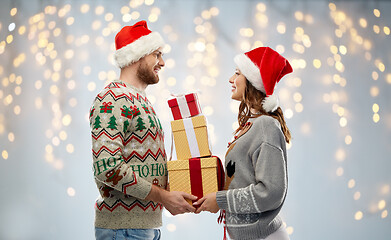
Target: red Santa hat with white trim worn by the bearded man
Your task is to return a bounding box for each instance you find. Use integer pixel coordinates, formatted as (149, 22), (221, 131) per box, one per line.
(114, 21), (164, 68)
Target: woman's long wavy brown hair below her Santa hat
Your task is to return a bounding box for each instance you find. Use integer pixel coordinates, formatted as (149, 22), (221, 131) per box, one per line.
(236, 79), (291, 143)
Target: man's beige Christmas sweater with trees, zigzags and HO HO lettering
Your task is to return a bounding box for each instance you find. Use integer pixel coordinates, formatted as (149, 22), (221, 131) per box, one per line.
(90, 80), (167, 229)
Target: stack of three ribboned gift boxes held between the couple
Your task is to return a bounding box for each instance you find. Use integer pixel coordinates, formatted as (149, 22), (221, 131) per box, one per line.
(167, 93), (224, 202)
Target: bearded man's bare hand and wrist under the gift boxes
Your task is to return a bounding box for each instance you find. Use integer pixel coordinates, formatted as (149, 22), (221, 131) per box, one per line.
(145, 185), (197, 215)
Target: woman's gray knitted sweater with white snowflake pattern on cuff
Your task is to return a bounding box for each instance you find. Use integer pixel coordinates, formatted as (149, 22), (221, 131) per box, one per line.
(216, 115), (288, 239)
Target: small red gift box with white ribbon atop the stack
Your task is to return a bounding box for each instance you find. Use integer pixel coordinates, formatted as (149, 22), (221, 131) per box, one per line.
(168, 93), (201, 120)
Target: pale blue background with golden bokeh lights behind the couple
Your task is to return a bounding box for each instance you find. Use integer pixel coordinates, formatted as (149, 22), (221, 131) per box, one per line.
(0, 0), (391, 240)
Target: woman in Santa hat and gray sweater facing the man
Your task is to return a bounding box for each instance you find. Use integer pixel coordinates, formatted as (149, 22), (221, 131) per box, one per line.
(194, 47), (292, 240)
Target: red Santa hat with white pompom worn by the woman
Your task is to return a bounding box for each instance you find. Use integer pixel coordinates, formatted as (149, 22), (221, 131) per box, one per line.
(234, 47), (293, 112)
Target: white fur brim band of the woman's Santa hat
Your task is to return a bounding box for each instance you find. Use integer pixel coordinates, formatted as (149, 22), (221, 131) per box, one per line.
(234, 53), (265, 93)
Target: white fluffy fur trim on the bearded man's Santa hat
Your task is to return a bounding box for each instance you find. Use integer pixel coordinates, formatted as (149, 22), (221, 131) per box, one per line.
(114, 32), (164, 68)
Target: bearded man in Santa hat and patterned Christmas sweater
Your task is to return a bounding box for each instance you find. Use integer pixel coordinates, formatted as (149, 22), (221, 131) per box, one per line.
(90, 21), (197, 240)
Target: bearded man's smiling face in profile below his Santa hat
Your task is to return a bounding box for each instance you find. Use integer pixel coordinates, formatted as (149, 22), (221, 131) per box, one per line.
(137, 48), (164, 85)
